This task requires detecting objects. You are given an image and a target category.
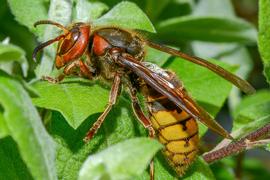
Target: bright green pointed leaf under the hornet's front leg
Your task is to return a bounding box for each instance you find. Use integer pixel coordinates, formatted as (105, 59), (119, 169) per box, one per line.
(33, 78), (109, 129)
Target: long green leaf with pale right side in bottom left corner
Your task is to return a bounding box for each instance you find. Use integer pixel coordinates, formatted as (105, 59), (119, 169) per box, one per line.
(0, 72), (56, 179)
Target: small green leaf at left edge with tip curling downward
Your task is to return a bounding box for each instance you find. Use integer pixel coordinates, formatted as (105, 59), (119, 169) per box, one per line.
(0, 43), (28, 76)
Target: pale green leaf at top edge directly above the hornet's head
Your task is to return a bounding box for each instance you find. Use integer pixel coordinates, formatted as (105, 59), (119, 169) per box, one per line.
(75, 0), (109, 22)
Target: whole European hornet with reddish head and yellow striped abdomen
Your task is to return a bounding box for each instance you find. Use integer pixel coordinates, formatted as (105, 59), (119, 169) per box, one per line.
(33, 20), (255, 179)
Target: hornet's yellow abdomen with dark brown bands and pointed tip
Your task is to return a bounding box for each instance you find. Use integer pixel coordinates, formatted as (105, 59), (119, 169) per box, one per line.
(147, 87), (199, 176)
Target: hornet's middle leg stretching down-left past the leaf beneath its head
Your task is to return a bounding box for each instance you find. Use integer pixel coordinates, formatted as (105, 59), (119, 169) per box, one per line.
(84, 74), (121, 142)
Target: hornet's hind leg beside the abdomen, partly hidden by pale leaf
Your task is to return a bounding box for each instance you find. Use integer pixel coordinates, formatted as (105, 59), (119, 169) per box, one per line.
(128, 84), (155, 180)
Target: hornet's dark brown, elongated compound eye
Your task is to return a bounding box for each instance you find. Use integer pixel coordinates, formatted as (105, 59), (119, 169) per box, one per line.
(58, 29), (80, 55)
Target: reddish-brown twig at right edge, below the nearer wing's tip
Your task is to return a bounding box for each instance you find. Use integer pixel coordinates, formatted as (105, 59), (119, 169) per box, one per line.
(203, 124), (270, 163)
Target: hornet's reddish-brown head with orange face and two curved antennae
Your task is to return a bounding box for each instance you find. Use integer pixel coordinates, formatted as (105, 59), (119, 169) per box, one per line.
(33, 20), (91, 69)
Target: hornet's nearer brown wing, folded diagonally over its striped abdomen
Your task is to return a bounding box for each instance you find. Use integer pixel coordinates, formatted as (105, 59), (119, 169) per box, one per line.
(118, 55), (233, 139)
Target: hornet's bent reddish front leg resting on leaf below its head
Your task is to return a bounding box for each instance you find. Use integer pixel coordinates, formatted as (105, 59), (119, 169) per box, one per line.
(42, 60), (93, 83)
